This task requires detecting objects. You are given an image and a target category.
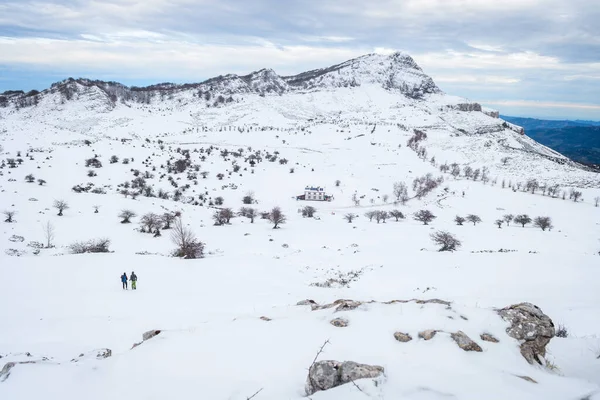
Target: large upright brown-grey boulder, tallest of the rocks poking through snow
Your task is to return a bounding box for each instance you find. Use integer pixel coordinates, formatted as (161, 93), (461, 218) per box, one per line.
(498, 303), (555, 364)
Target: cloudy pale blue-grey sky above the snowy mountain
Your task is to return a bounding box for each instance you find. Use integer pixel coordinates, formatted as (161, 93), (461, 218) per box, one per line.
(0, 0), (600, 120)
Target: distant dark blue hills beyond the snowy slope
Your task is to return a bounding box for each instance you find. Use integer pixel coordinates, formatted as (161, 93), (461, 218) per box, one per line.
(501, 116), (600, 165)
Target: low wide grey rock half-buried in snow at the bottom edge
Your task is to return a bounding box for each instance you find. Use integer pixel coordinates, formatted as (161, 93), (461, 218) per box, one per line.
(306, 360), (384, 396)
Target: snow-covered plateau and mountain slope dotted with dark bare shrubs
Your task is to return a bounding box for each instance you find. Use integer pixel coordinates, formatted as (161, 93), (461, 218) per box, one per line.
(0, 53), (600, 400)
